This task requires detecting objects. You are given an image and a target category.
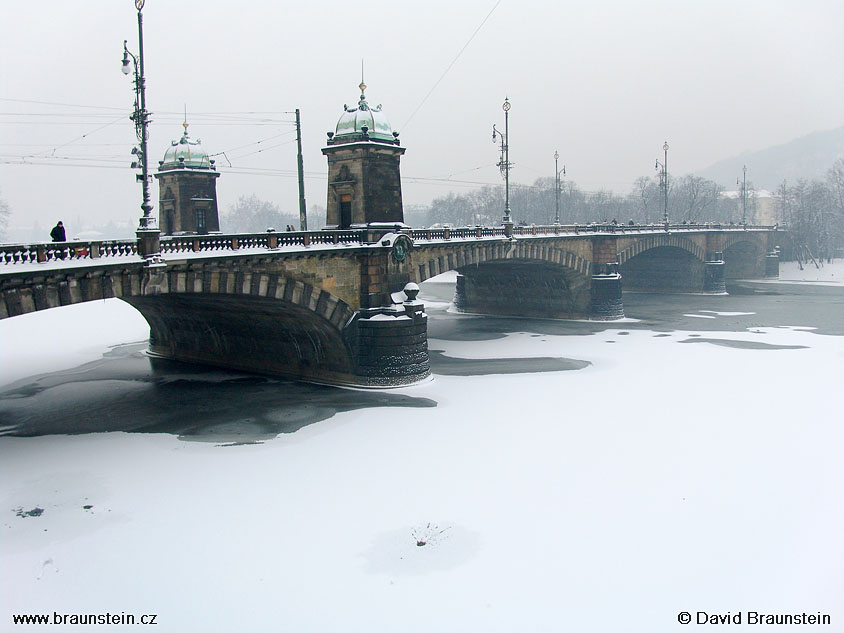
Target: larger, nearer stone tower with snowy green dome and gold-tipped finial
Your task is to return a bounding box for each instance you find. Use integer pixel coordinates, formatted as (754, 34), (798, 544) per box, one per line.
(322, 81), (405, 229)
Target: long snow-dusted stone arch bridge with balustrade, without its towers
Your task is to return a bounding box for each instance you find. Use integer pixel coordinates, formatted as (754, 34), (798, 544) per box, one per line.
(0, 224), (778, 387)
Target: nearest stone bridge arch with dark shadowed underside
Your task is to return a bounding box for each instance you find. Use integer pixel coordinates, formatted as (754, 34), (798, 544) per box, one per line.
(121, 271), (356, 383)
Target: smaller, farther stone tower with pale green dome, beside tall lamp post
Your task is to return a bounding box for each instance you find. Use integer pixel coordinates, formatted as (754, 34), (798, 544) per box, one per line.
(154, 122), (220, 235)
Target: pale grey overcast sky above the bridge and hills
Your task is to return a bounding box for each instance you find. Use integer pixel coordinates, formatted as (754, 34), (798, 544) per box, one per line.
(0, 0), (844, 237)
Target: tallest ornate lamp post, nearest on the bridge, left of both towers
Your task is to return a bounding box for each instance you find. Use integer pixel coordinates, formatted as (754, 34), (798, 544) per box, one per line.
(122, 0), (161, 259)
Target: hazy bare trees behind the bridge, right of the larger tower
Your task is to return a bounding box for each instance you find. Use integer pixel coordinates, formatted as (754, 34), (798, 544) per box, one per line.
(406, 158), (844, 259)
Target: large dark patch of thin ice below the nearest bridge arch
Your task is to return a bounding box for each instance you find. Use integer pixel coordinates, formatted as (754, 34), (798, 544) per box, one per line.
(0, 344), (437, 444)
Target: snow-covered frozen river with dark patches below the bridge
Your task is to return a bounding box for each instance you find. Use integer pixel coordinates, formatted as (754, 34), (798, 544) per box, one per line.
(0, 263), (844, 632)
